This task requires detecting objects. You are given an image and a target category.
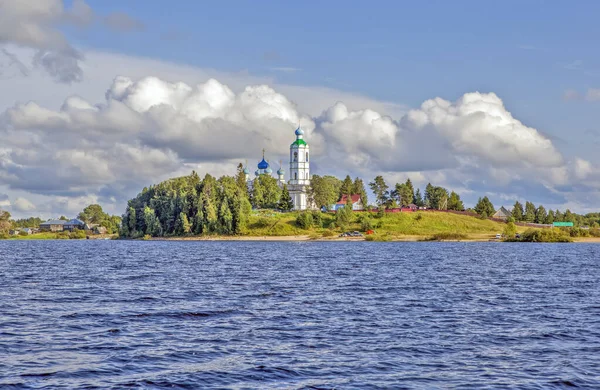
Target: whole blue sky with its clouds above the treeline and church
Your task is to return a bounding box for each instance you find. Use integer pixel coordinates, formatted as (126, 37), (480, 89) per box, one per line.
(0, 0), (600, 218)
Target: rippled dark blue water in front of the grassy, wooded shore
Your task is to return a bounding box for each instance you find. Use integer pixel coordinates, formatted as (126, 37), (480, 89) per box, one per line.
(0, 241), (600, 389)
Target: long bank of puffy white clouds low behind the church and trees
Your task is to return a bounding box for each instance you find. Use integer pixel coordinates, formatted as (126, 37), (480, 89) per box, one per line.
(0, 48), (594, 216)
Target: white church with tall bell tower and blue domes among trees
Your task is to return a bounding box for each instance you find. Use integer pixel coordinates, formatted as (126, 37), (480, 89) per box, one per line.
(244, 126), (312, 210)
